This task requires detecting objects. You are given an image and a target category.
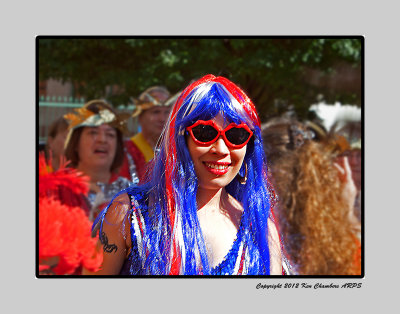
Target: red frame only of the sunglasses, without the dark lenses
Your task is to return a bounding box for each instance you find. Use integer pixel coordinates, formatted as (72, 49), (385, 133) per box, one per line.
(186, 120), (253, 149)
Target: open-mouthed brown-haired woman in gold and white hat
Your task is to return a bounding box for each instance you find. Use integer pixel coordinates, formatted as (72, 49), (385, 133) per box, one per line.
(64, 100), (131, 220)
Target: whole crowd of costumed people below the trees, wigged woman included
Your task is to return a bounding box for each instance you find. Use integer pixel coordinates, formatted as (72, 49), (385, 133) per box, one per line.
(39, 75), (362, 276)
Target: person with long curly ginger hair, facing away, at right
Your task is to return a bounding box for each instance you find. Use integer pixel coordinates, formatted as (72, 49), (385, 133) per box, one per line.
(262, 118), (361, 276)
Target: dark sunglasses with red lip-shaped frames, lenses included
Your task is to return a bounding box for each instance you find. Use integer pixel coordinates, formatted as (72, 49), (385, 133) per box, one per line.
(186, 120), (253, 149)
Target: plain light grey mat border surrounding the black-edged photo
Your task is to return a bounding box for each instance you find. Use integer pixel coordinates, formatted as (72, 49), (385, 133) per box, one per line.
(0, 0), (400, 313)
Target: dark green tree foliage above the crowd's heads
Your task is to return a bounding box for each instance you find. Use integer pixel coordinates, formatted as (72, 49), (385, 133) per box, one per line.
(37, 37), (363, 119)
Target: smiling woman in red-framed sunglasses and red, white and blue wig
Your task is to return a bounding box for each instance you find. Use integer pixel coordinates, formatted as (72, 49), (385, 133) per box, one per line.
(93, 75), (282, 275)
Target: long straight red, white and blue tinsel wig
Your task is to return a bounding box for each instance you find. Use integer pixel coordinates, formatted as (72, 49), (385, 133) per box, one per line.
(103, 75), (270, 275)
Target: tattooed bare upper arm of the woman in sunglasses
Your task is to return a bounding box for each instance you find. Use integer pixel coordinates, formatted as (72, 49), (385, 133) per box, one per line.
(84, 194), (130, 275)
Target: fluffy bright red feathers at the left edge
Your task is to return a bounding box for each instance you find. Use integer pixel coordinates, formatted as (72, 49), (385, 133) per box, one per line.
(39, 155), (103, 275)
